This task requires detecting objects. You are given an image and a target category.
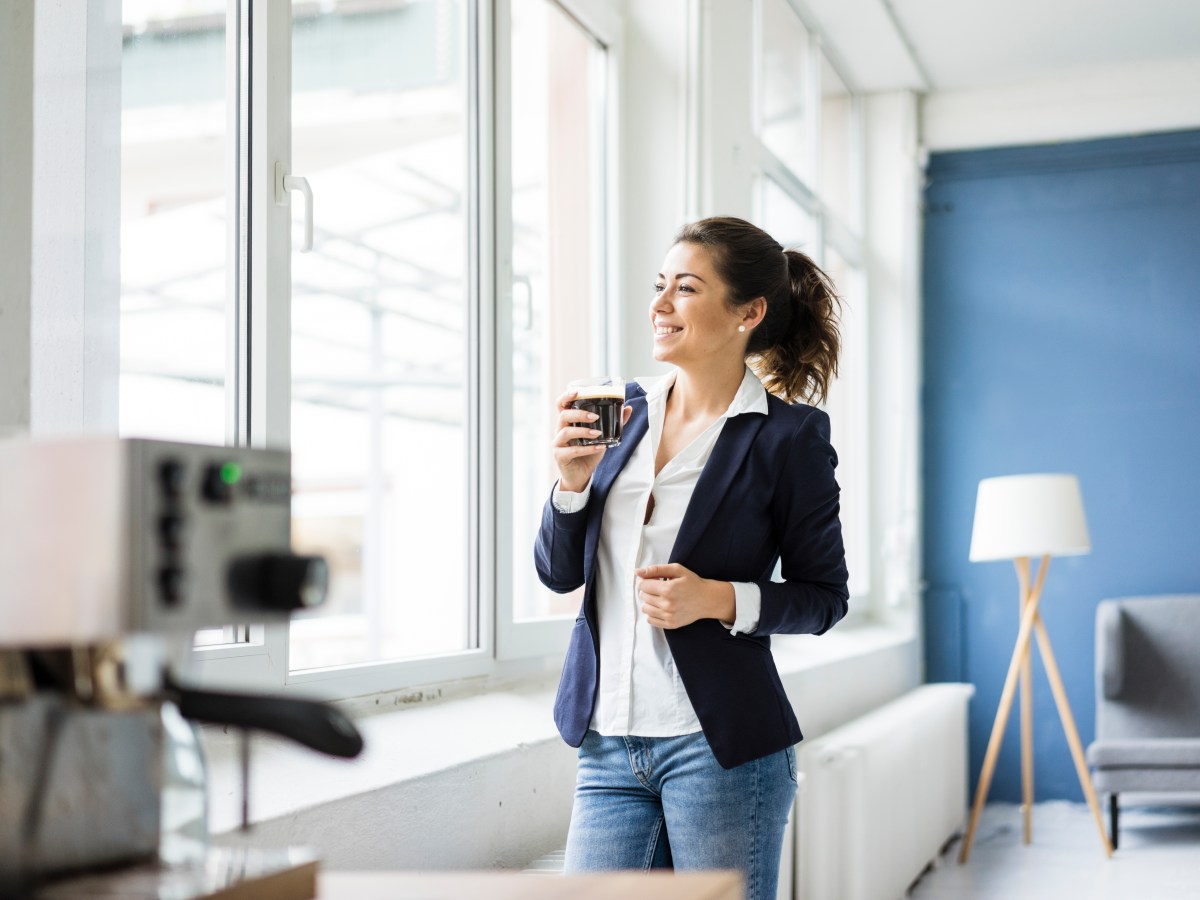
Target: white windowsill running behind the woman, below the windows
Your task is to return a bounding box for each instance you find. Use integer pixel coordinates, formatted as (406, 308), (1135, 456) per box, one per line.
(203, 623), (916, 834)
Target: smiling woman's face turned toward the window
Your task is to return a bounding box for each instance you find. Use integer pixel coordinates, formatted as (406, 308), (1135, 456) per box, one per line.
(650, 242), (746, 368)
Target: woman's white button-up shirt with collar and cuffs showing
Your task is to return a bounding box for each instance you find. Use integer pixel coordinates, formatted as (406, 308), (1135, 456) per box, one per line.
(553, 367), (767, 737)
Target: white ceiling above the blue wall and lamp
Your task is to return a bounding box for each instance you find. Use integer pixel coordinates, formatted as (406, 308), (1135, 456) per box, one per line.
(797, 0), (1200, 92)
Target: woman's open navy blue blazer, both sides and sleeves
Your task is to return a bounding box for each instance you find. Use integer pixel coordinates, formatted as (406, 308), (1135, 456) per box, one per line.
(534, 383), (848, 768)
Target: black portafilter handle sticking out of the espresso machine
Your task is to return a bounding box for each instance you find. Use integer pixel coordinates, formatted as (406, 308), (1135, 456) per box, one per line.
(168, 682), (362, 760)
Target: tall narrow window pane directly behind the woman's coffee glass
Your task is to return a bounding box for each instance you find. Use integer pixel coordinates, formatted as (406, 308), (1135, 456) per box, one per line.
(511, 0), (605, 620)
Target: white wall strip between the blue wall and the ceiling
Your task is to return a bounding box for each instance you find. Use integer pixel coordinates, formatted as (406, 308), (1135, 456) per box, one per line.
(922, 60), (1200, 150)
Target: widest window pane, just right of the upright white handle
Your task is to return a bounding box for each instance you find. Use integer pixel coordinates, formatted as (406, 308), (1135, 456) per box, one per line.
(290, 0), (473, 670)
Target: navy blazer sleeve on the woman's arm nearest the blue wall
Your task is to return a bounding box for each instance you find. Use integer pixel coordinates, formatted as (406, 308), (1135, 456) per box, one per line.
(755, 409), (850, 635)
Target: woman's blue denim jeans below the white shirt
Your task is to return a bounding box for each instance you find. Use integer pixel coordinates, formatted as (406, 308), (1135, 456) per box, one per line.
(565, 731), (796, 900)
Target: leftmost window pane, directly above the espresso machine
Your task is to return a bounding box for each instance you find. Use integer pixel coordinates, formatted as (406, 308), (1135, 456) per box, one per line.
(120, 0), (230, 444)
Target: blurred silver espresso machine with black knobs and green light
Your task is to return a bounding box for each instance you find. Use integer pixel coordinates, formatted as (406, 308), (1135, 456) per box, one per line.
(0, 438), (362, 900)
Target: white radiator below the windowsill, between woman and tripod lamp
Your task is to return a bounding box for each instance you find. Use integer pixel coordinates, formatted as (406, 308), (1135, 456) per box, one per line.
(796, 684), (974, 900)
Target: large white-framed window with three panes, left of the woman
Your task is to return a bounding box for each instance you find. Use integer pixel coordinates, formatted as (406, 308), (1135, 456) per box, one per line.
(120, 0), (612, 696)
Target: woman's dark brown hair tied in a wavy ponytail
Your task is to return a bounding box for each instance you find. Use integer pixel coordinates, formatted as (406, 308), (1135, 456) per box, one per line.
(676, 216), (841, 403)
